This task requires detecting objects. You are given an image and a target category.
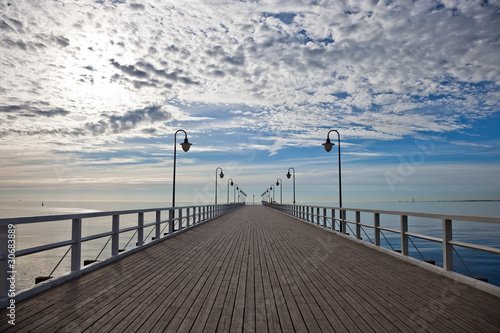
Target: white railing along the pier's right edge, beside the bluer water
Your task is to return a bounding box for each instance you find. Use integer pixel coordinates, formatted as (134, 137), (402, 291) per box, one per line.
(266, 204), (500, 282)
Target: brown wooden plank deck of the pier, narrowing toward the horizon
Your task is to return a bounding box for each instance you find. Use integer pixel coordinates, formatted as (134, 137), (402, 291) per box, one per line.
(0, 206), (500, 332)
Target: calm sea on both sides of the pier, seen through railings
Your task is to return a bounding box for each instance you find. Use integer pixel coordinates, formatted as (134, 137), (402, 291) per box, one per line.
(0, 201), (500, 292)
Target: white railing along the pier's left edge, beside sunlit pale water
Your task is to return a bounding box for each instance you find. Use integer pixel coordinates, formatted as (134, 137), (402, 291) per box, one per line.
(0, 203), (244, 300)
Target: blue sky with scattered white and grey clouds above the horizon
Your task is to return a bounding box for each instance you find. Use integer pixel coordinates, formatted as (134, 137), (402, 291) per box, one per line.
(0, 0), (500, 206)
